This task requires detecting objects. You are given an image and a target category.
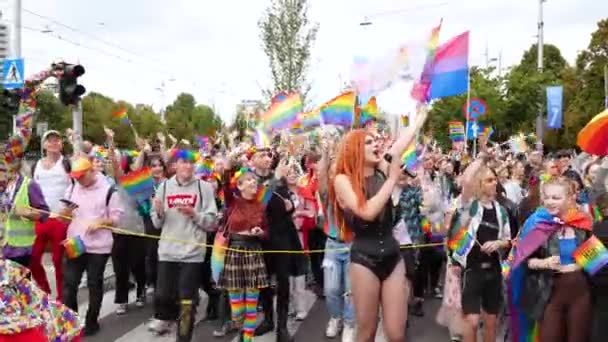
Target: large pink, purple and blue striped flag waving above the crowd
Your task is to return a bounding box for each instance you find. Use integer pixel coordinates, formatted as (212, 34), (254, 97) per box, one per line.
(429, 31), (469, 100)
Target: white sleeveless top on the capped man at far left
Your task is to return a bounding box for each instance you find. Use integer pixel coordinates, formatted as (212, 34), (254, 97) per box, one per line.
(34, 157), (72, 213)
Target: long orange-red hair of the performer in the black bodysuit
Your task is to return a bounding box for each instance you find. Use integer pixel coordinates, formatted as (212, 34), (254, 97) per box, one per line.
(328, 129), (368, 240)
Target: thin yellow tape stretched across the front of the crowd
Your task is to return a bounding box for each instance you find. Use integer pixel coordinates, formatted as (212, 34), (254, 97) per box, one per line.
(29, 207), (446, 254)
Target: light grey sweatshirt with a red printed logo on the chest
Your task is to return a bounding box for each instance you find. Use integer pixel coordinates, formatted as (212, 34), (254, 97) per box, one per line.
(151, 176), (217, 263)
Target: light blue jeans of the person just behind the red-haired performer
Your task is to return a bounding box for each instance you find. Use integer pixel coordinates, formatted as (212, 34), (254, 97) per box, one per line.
(323, 239), (355, 327)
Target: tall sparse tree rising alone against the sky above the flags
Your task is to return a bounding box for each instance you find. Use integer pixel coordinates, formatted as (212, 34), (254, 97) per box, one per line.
(259, 0), (319, 99)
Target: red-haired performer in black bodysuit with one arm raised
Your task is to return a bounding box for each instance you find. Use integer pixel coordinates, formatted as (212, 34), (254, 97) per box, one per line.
(329, 112), (426, 342)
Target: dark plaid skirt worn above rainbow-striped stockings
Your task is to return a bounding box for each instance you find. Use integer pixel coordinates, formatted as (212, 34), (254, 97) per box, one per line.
(219, 241), (269, 290)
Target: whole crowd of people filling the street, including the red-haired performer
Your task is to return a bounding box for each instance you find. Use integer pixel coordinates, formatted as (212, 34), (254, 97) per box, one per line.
(0, 107), (608, 342)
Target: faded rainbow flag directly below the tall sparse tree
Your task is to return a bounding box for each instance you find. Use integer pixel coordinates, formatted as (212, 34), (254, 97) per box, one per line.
(260, 94), (302, 131)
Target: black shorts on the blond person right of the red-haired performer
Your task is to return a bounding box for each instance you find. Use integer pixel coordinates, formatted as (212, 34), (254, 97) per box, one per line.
(462, 267), (503, 315)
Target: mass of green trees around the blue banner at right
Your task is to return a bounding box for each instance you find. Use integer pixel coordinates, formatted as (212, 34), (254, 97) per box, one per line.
(425, 19), (608, 150)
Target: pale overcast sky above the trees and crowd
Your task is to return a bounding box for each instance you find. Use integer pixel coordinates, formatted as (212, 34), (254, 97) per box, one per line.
(0, 0), (608, 122)
